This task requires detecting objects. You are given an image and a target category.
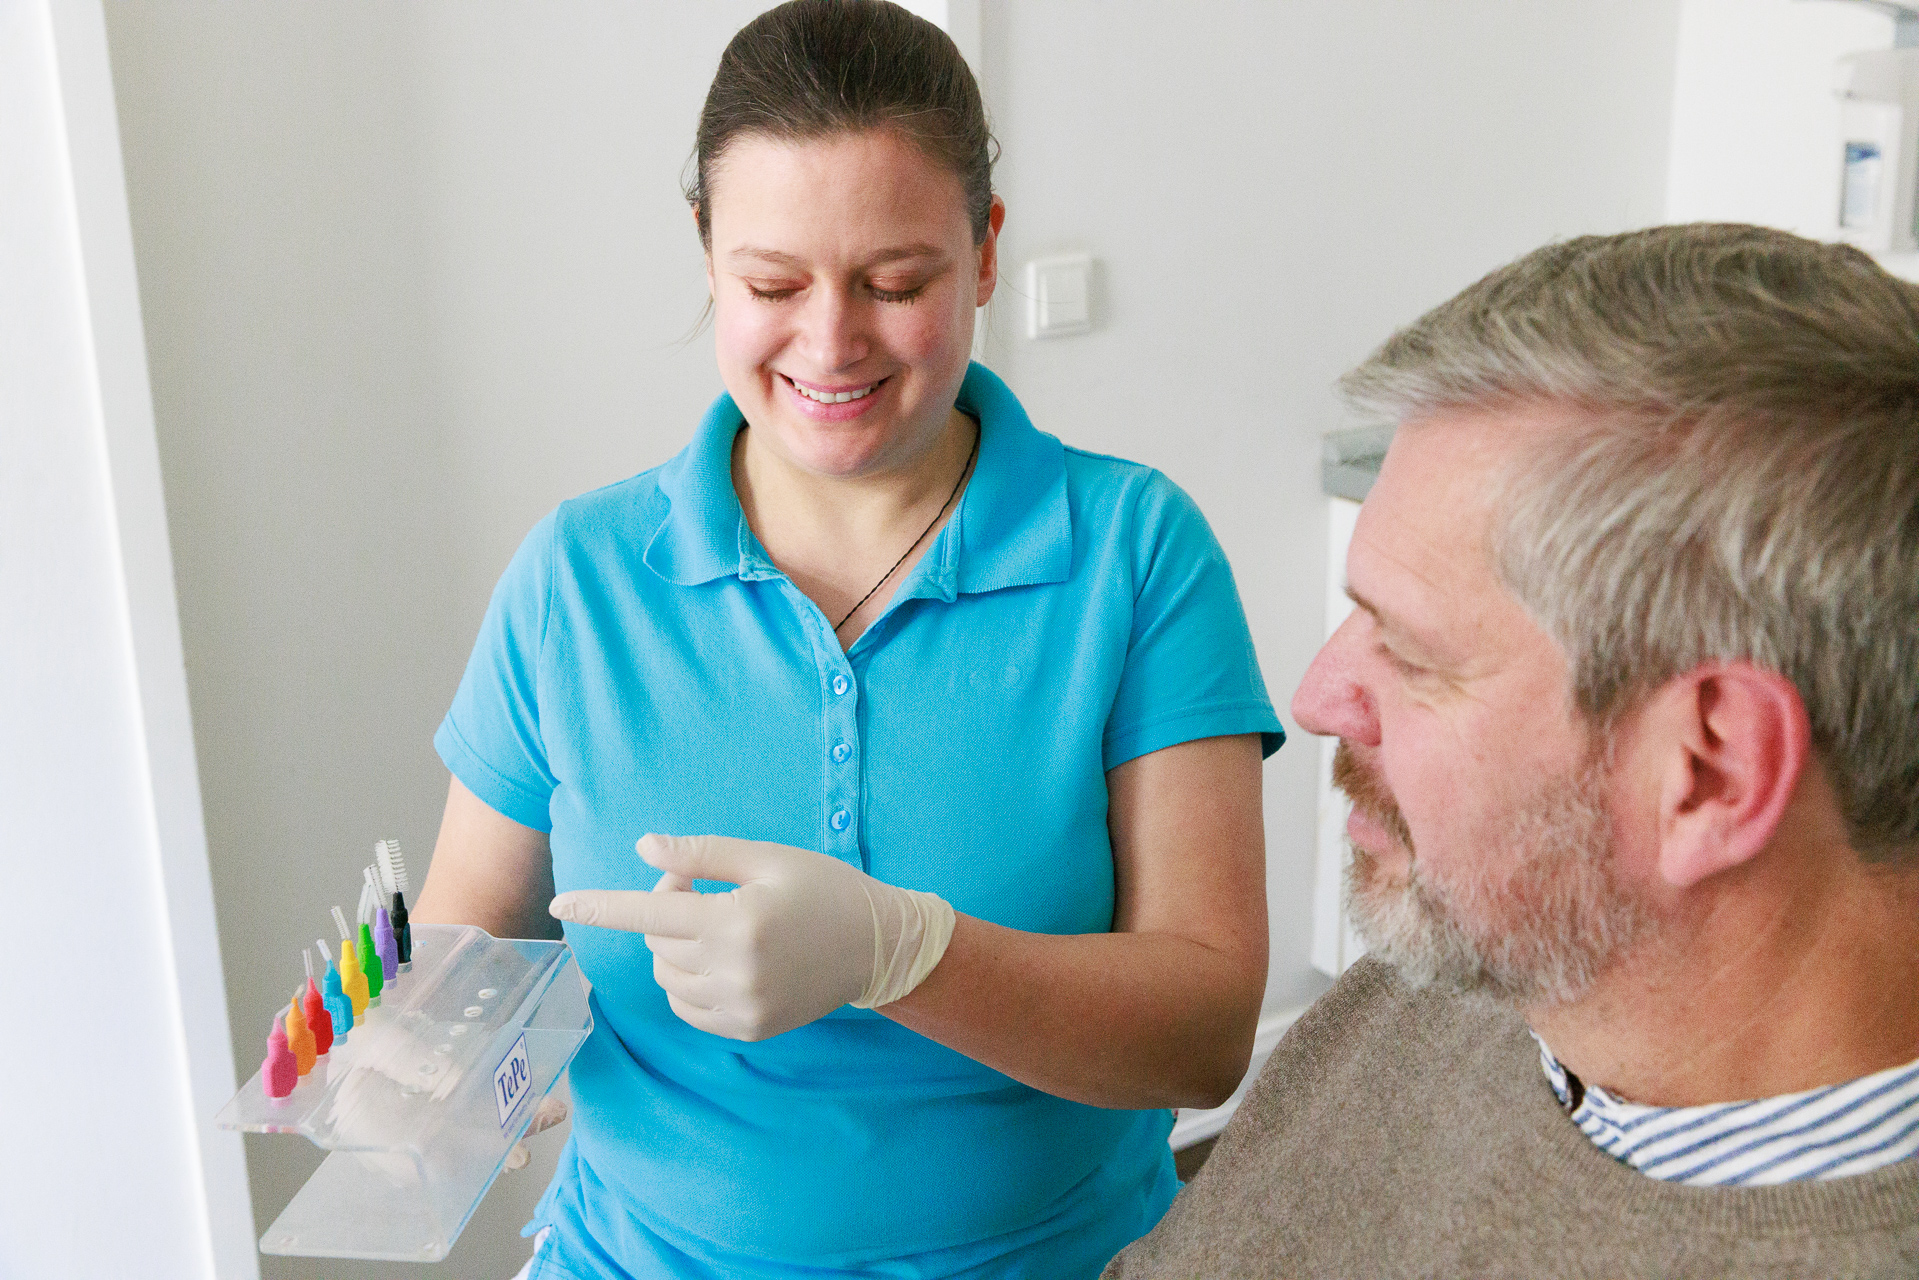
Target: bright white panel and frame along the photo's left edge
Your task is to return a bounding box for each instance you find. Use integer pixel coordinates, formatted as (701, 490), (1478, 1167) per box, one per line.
(0, 0), (257, 1280)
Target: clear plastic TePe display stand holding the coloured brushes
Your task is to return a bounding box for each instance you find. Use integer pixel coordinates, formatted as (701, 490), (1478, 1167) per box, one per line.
(215, 925), (593, 1263)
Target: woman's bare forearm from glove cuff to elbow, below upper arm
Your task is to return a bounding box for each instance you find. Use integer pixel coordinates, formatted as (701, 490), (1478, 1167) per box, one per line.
(881, 915), (1267, 1107)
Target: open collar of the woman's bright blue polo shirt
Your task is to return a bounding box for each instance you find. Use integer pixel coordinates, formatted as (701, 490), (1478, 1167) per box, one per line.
(643, 363), (1073, 601)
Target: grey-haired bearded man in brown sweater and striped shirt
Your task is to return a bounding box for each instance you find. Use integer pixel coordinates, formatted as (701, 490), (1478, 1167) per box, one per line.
(1107, 226), (1919, 1280)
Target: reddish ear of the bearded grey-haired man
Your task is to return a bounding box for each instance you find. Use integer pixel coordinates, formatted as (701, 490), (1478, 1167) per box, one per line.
(1641, 662), (1812, 889)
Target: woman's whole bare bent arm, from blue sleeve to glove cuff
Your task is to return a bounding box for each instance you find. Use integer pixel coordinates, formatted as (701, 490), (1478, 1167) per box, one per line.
(881, 733), (1267, 1107)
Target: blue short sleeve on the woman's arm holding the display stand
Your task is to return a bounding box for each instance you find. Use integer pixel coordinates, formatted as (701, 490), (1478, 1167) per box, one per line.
(434, 512), (558, 831)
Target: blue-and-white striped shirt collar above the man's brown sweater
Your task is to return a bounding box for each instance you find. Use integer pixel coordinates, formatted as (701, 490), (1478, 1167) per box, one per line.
(1533, 1034), (1919, 1186)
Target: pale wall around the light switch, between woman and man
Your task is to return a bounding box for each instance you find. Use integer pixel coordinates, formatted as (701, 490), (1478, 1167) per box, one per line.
(981, 0), (1677, 1011)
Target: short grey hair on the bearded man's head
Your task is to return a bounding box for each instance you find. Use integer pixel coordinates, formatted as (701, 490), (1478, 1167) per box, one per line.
(1341, 225), (1919, 860)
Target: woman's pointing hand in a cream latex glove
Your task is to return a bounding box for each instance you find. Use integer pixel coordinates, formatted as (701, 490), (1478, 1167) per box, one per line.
(549, 835), (954, 1040)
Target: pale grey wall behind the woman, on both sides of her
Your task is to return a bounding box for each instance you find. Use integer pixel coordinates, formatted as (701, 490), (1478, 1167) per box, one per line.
(97, 0), (1677, 1278)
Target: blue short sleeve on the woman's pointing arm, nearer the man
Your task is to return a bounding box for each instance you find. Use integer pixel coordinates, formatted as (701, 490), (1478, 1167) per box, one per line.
(1103, 472), (1286, 770)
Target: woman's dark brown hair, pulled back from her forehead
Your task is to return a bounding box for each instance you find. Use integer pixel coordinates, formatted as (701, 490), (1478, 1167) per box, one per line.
(685, 0), (998, 248)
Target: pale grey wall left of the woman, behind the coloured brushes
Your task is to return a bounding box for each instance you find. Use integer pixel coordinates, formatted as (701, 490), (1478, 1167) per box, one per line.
(107, 0), (758, 1280)
